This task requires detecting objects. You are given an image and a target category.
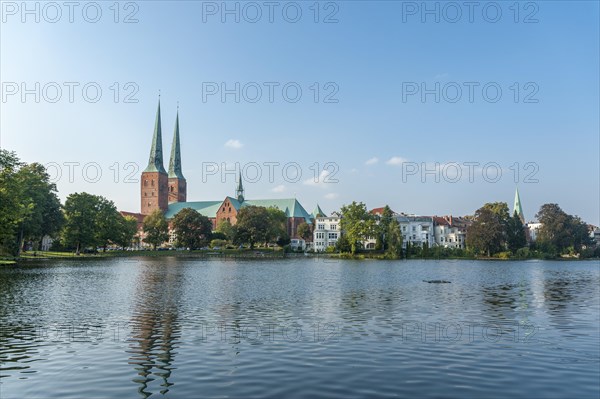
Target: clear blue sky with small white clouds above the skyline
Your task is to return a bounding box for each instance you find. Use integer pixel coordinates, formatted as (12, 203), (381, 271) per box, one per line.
(0, 1), (600, 225)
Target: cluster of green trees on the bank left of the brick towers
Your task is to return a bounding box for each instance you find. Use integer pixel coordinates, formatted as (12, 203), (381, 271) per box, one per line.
(0, 150), (137, 256)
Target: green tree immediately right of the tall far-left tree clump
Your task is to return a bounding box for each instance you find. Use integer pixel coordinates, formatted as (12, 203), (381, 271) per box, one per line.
(63, 193), (100, 255)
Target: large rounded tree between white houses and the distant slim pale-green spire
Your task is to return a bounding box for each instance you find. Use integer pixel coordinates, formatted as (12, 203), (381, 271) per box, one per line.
(467, 204), (506, 256)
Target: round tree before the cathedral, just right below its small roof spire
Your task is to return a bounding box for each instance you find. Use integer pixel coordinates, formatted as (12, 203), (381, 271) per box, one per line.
(234, 206), (272, 249)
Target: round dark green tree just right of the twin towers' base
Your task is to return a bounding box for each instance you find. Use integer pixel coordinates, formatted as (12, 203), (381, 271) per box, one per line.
(172, 208), (212, 251)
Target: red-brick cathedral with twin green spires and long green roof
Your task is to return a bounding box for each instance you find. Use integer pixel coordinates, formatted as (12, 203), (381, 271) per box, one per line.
(122, 100), (323, 238)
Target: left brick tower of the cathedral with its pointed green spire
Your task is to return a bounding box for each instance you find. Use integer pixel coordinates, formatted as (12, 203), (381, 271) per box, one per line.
(140, 98), (169, 215)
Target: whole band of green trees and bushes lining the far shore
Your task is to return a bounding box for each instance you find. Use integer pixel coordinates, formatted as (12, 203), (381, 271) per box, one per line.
(0, 150), (600, 261)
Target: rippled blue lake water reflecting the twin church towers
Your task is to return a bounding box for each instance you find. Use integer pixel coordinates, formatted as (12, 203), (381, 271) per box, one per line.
(0, 258), (600, 399)
